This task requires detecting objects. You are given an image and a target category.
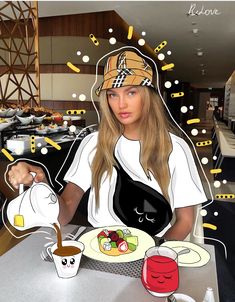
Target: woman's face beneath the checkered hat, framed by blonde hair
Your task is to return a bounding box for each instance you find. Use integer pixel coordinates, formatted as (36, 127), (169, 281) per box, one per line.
(107, 86), (143, 129)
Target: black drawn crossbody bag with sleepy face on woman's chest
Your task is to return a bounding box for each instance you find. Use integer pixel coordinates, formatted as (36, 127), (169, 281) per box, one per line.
(113, 165), (172, 235)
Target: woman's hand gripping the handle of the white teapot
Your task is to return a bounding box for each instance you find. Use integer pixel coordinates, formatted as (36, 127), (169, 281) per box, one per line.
(7, 162), (47, 189)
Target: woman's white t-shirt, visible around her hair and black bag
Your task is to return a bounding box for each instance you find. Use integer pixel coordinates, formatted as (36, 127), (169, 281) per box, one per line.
(64, 132), (207, 236)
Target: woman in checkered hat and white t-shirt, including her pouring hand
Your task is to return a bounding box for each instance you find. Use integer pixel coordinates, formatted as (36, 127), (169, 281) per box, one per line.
(9, 51), (206, 240)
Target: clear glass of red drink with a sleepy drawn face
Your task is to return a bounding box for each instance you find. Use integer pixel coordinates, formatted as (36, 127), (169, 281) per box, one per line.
(141, 246), (179, 297)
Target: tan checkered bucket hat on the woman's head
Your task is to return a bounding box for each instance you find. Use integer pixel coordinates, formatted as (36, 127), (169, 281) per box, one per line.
(96, 51), (154, 96)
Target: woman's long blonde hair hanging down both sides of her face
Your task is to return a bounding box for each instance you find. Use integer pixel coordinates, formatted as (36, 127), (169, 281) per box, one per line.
(91, 86), (173, 205)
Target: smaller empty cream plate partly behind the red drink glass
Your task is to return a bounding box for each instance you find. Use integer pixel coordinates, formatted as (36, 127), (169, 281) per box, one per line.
(161, 241), (210, 267)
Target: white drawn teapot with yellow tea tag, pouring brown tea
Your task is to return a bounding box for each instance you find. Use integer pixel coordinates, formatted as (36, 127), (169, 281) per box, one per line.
(7, 178), (59, 231)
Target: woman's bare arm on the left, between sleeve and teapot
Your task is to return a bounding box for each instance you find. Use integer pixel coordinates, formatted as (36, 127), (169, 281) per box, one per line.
(58, 182), (84, 225)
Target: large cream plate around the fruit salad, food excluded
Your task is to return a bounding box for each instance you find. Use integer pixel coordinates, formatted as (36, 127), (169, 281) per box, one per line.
(79, 226), (155, 263)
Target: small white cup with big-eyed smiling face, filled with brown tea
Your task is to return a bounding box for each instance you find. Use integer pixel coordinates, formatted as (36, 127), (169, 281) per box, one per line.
(47, 240), (84, 278)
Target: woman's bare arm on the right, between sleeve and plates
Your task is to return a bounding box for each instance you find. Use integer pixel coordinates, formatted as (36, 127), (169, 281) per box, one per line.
(164, 206), (194, 240)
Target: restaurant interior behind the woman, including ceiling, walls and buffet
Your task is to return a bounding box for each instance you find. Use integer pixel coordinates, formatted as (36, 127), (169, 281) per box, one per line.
(0, 1), (235, 302)
